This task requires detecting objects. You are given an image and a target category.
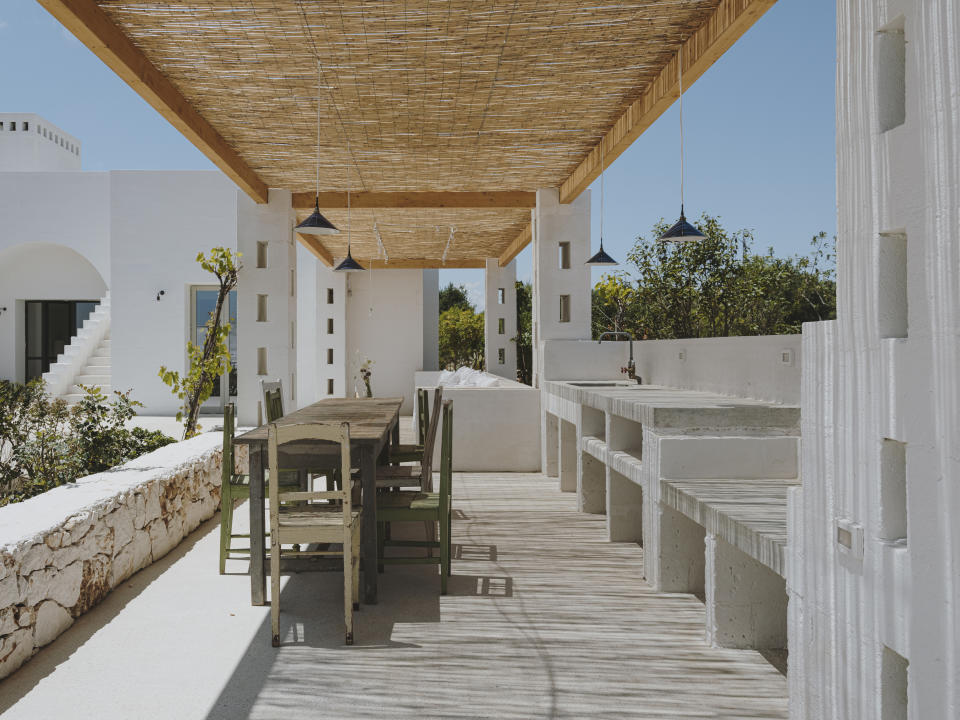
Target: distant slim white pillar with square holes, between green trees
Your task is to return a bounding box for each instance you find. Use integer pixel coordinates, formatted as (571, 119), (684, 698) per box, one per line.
(483, 258), (517, 380)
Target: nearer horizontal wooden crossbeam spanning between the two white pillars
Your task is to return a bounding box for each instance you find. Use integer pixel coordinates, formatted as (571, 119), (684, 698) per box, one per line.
(293, 190), (537, 210)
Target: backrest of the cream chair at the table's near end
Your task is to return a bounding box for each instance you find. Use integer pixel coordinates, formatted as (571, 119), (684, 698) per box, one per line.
(267, 423), (353, 528)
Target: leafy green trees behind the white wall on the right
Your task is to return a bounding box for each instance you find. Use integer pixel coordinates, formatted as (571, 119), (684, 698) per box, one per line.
(592, 215), (836, 339)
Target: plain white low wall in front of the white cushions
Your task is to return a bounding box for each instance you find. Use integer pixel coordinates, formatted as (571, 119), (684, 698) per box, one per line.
(414, 372), (540, 472)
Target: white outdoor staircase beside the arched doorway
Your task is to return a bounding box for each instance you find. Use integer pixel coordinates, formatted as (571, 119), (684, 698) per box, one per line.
(43, 290), (110, 405)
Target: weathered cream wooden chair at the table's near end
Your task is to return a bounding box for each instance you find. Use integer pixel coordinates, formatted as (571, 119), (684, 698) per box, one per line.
(267, 423), (361, 647)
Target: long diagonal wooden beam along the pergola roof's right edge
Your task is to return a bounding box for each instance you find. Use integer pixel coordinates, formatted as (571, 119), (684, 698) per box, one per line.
(560, 0), (776, 203)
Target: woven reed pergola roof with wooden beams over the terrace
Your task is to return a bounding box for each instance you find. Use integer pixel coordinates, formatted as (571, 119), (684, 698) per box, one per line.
(39, 0), (775, 266)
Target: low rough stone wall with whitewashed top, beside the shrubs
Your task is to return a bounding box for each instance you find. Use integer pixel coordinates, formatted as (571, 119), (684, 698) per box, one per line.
(0, 433), (221, 678)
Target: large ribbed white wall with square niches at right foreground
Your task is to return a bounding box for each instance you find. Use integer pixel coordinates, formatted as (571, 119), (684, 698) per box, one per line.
(788, 0), (960, 720)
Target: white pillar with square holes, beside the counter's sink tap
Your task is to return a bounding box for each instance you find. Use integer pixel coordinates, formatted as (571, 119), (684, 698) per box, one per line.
(532, 188), (591, 387)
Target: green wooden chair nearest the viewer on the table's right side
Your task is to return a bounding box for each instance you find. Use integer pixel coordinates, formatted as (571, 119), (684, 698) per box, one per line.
(377, 400), (453, 595)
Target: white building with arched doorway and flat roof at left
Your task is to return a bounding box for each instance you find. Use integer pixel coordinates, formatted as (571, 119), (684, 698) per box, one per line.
(0, 114), (437, 423)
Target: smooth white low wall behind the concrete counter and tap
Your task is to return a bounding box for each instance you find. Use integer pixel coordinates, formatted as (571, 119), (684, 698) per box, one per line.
(541, 335), (801, 405)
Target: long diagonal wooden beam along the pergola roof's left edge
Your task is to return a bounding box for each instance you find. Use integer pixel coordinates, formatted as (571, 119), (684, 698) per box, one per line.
(38, 0), (268, 203)
